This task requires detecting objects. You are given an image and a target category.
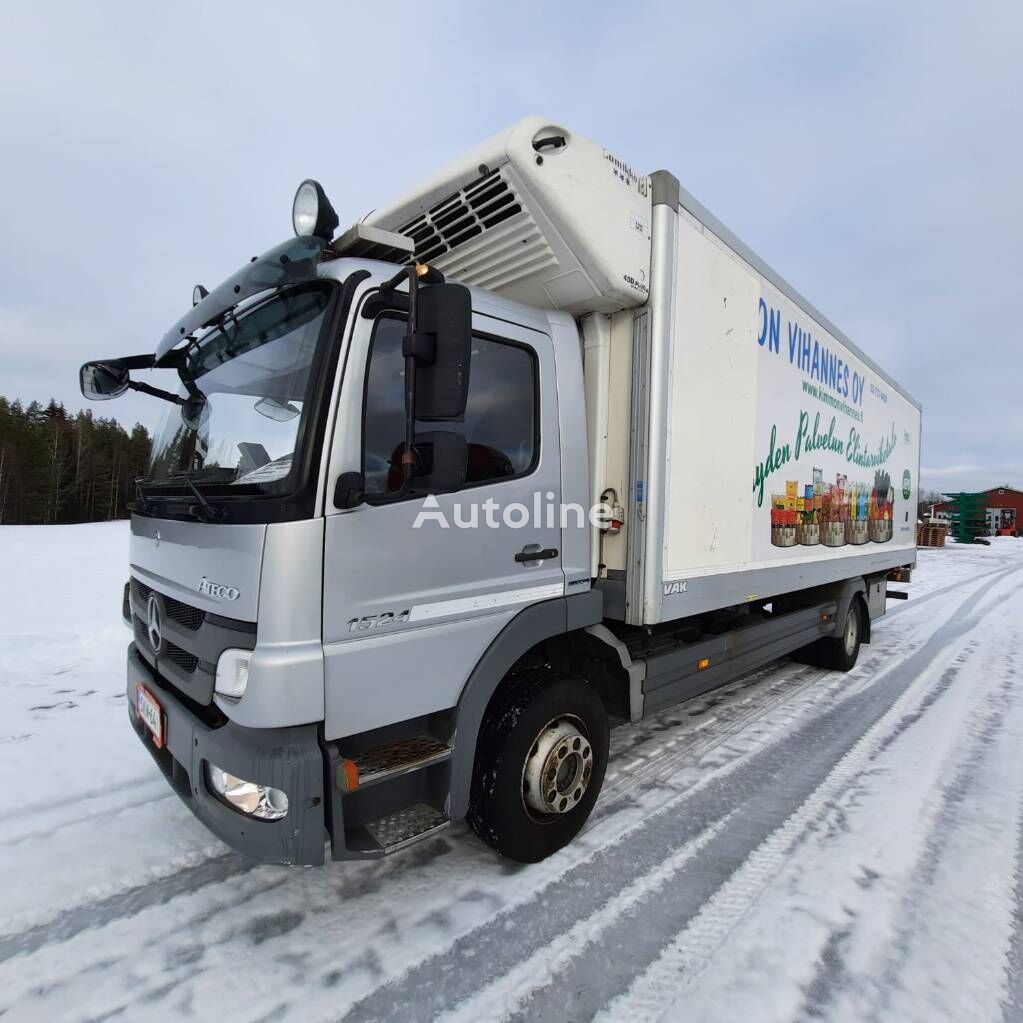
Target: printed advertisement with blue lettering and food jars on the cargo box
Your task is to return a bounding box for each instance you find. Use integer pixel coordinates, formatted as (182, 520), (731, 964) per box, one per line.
(753, 285), (920, 561)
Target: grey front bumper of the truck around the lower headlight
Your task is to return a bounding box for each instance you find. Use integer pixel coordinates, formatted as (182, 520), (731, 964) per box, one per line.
(127, 643), (327, 864)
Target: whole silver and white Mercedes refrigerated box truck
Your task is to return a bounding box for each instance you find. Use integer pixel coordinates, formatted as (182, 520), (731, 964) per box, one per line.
(81, 118), (920, 863)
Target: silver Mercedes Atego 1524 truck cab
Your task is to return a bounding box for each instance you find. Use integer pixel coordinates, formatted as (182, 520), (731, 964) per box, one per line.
(83, 215), (606, 863)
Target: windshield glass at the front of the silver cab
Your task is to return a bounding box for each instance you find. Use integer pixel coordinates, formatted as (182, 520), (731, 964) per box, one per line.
(147, 284), (329, 490)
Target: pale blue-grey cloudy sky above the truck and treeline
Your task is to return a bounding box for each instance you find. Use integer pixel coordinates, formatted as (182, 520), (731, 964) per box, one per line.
(0, 0), (1023, 491)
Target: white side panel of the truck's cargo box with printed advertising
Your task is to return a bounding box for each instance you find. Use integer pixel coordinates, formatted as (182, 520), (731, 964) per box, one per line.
(643, 196), (921, 623)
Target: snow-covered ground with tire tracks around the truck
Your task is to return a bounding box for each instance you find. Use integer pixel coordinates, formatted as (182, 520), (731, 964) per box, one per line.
(0, 524), (1023, 1023)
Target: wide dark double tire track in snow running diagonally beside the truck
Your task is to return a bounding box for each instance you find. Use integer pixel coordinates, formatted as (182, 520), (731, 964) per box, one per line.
(346, 564), (1014, 1020)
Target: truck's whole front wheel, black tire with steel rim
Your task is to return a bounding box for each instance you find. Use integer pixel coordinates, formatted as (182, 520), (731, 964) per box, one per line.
(468, 671), (609, 863)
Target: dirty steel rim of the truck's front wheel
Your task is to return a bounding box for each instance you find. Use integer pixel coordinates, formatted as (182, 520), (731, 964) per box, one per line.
(522, 716), (593, 817)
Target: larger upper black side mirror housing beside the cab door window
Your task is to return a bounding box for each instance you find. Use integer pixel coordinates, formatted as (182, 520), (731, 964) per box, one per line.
(415, 284), (473, 421)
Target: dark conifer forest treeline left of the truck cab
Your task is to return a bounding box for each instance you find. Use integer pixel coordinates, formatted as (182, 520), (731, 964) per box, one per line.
(0, 396), (149, 526)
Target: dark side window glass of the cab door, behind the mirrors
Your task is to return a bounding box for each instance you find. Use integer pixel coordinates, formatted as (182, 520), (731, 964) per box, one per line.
(362, 316), (539, 493)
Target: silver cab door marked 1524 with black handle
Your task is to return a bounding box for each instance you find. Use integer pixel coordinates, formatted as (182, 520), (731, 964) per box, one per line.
(323, 298), (565, 739)
